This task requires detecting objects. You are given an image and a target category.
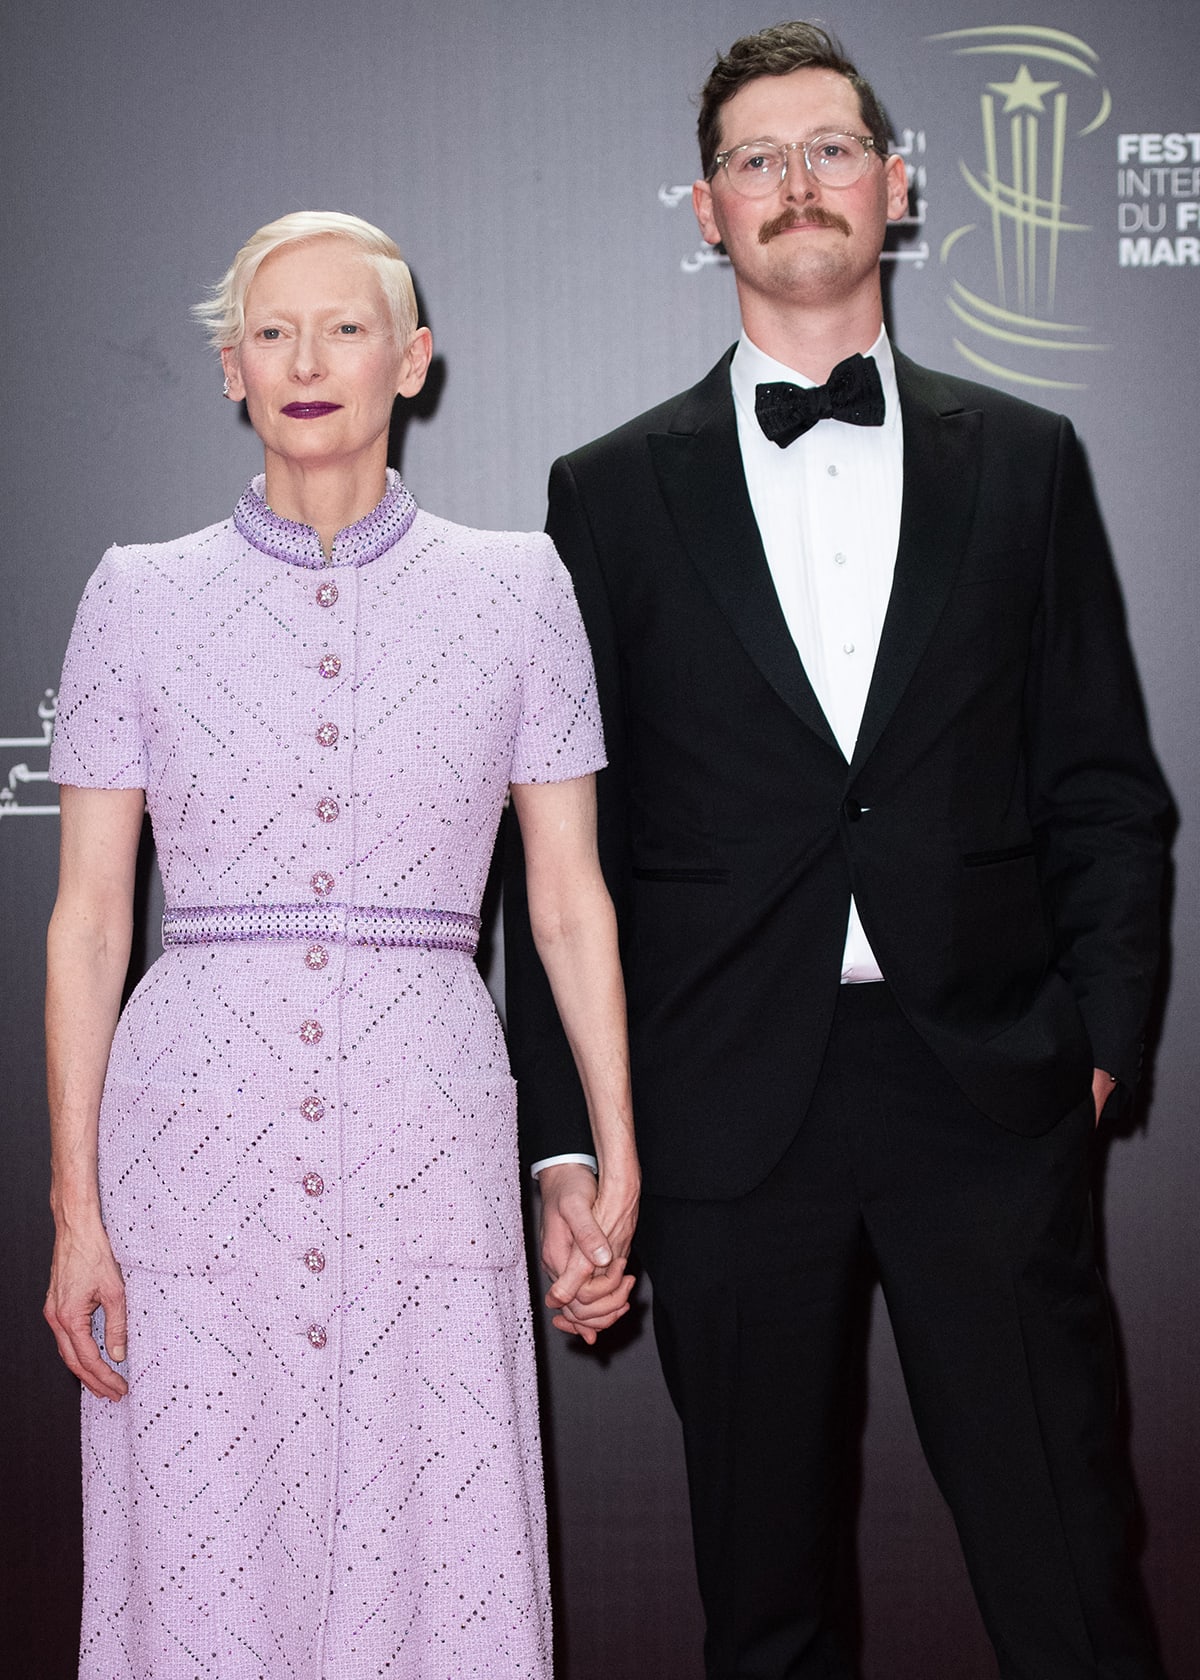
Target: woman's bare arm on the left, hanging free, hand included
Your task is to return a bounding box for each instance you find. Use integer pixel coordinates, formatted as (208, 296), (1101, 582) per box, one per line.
(45, 786), (146, 1399)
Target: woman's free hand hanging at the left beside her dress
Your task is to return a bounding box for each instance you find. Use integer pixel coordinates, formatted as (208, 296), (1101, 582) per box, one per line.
(42, 1216), (129, 1399)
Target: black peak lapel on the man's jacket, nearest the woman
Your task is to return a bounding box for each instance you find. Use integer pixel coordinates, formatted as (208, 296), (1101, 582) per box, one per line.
(647, 353), (840, 756)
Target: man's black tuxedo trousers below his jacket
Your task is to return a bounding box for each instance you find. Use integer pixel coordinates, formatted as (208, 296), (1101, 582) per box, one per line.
(639, 986), (1163, 1680)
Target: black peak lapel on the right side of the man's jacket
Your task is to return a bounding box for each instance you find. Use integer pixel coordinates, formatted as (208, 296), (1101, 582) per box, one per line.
(850, 353), (980, 774)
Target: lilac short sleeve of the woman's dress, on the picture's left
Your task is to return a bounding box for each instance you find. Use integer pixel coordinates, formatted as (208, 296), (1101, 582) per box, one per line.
(50, 548), (150, 788)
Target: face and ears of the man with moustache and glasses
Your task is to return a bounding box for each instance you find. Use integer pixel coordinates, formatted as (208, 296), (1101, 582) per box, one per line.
(692, 69), (908, 315)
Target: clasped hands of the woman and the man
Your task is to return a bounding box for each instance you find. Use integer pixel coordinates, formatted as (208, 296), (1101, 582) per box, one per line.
(538, 1163), (640, 1346)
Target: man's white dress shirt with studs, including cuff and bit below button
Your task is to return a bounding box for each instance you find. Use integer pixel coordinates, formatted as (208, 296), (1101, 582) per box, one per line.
(531, 331), (904, 1178)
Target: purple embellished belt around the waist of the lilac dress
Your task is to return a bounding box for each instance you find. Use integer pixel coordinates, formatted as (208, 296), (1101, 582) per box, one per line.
(163, 904), (479, 956)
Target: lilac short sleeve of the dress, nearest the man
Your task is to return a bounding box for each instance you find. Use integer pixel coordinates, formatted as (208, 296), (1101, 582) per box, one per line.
(509, 538), (607, 783)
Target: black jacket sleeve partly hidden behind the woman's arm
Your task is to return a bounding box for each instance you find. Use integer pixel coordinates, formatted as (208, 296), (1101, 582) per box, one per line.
(504, 460), (627, 1164)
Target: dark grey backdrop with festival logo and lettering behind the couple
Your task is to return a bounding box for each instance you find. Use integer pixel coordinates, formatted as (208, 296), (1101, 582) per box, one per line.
(0, 0), (1200, 1680)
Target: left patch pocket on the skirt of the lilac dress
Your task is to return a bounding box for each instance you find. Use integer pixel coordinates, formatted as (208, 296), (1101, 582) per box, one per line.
(99, 1079), (262, 1277)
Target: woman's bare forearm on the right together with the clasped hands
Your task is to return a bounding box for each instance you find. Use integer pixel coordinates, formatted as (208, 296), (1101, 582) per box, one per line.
(513, 776), (640, 1342)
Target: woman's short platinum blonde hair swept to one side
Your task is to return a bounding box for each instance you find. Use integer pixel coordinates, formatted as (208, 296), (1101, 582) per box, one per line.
(192, 210), (417, 349)
